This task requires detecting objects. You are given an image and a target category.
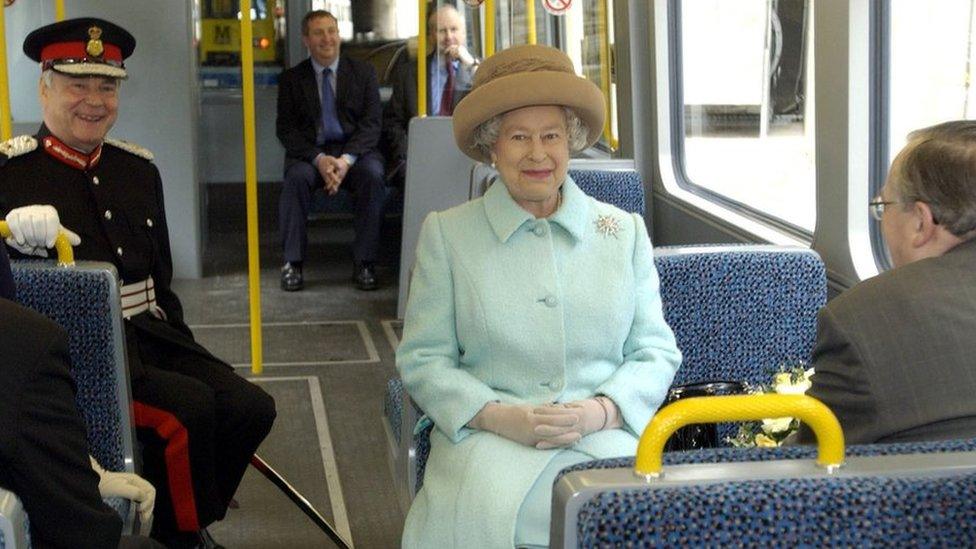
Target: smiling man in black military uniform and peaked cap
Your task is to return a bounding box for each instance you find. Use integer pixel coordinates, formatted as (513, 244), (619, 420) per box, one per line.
(0, 18), (275, 547)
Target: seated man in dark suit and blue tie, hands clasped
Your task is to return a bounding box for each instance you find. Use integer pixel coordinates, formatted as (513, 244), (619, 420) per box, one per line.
(277, 10), (386, 291)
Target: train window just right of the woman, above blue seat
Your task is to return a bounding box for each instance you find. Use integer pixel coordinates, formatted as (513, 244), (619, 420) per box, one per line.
(671, 0), (816, 235)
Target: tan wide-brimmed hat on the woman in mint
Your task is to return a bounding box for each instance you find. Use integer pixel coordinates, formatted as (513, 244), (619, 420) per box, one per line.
(454, 45), (605, 162)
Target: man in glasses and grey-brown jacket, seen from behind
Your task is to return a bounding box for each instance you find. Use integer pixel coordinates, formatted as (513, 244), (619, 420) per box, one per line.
(800, 120), (976, 443)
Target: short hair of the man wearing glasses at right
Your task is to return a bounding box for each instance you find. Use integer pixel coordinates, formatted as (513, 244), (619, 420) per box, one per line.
(890, 120), (976, 237)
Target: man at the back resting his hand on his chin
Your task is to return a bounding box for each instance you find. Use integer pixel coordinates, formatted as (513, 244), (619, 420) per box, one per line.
(383, 4), (478, 186)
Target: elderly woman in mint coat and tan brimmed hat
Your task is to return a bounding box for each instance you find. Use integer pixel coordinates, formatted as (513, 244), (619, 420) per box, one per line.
(397, 46), (681, 549)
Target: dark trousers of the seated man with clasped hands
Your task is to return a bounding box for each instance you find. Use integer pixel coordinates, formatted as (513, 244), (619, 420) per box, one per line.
(278, 145), (386, 262)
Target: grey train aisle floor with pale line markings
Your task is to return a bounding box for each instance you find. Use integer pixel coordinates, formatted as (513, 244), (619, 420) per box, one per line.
(174, 203), (404, 549)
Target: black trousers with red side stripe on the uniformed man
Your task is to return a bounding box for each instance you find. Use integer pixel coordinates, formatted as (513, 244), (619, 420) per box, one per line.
(127, 323), (276, 537)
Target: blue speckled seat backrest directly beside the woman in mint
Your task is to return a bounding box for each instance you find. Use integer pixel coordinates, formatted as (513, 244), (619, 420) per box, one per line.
(654, 245), (827, 385)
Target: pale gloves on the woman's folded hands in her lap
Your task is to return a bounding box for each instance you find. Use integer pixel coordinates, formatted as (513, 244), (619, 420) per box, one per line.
(468, 402), (580, 450)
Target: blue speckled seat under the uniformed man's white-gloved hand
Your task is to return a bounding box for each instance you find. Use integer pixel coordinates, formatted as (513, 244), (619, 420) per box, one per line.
(0, 261), (136, 548)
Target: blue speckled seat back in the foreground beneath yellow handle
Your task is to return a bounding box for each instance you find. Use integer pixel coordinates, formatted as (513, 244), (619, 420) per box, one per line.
(550, 439), (976, 547)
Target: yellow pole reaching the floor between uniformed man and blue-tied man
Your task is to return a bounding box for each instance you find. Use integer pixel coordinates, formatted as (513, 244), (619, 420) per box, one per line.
(241, 0), (264, 375)
